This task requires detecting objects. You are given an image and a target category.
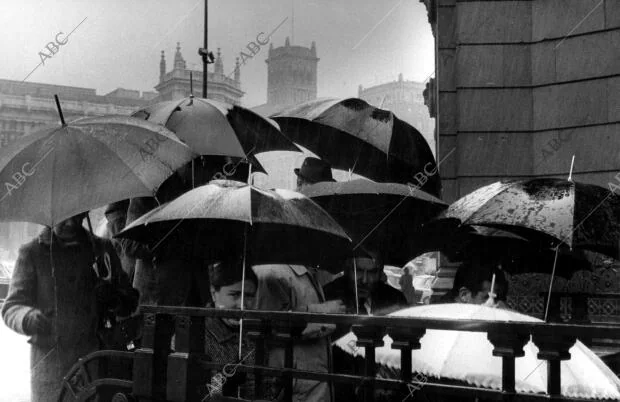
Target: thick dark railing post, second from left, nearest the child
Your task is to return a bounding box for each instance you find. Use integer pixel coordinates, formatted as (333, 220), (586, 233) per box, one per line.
(166, 315), (210, 402)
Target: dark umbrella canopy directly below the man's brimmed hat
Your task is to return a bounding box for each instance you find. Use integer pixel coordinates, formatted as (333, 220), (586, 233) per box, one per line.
(301, 179), (447, 266)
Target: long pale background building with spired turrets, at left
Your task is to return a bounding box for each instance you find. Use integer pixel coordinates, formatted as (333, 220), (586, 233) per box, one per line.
(0, 43), (243, 257)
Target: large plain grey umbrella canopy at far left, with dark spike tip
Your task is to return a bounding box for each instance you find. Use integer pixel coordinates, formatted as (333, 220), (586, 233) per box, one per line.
(0, 116), (195, 226)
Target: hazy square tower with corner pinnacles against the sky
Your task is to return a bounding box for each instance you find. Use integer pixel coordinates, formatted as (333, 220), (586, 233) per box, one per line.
(265, 37), (319, 106)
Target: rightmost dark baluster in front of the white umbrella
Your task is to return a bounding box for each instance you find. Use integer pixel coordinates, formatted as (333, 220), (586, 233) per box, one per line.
(532, 326), (577, 397)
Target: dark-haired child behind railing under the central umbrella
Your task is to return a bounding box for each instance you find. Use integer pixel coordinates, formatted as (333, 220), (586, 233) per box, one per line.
(205, 258), (258, 400)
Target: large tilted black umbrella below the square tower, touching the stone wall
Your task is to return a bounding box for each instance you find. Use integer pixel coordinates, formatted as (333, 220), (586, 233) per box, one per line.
(271, 98), (440, 196)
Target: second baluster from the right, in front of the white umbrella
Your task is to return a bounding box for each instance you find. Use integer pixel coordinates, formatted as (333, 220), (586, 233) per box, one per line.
(487, 326), (530, 400)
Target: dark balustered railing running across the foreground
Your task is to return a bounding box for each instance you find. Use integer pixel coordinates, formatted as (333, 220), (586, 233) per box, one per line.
(120, 306), (620, 402)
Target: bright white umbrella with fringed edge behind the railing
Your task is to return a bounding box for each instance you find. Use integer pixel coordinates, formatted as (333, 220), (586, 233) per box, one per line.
(335, 304), (620, 399)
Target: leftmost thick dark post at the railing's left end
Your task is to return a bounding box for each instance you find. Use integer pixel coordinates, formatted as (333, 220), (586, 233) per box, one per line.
(133, 313), (171, 401)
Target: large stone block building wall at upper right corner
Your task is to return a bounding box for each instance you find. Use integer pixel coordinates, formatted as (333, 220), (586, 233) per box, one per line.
(422, 0), (620, 296)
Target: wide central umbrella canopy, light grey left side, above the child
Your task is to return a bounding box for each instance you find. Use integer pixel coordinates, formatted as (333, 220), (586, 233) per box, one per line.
(117, 180), (352, 264)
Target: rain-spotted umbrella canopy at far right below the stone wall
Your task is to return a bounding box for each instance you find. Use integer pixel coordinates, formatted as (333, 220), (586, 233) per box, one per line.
(443, 178), (620, 257)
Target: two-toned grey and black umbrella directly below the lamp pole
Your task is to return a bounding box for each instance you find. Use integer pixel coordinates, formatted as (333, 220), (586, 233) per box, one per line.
(133, 96), (301, 171)
